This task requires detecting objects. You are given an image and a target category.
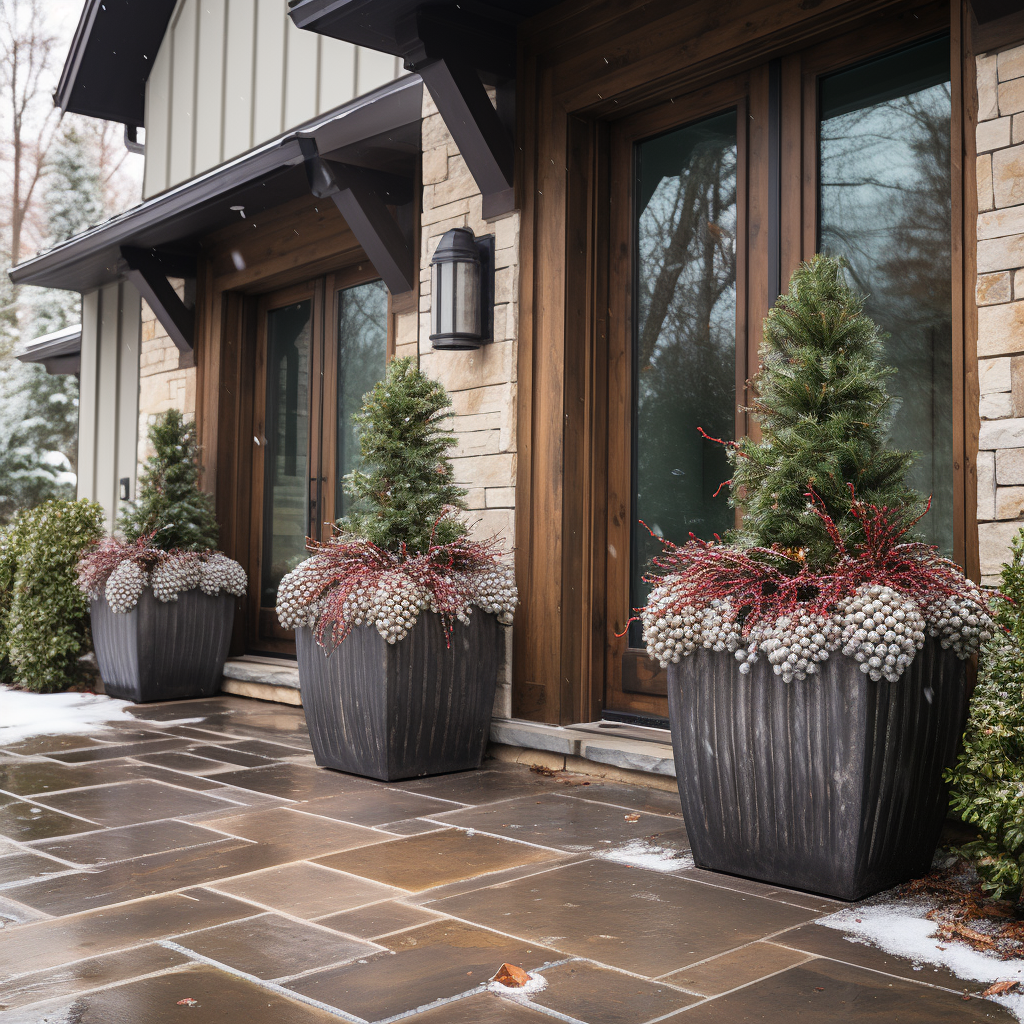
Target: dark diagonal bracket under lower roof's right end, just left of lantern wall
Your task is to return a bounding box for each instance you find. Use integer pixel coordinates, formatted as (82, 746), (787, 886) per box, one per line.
(306, 140), (418, 295)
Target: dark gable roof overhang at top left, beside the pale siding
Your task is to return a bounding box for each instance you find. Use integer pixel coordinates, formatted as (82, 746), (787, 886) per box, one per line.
(53, 0), (175, 127)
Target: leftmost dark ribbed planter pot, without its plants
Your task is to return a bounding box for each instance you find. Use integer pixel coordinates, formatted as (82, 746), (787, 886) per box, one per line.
(91, 587), (234, 703)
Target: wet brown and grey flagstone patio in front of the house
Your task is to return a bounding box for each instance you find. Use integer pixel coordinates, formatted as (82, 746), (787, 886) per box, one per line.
(0, 696), (1014, 1024)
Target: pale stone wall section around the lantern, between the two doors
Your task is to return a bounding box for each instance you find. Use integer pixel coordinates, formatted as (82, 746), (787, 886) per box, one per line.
(411, 90), (519, 718)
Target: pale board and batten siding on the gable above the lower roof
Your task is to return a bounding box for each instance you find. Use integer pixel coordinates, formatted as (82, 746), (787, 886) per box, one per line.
(143, 0), (402, 198)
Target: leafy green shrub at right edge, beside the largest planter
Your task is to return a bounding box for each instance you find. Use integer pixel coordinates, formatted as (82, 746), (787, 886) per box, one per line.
(946, 530), (1024, 901)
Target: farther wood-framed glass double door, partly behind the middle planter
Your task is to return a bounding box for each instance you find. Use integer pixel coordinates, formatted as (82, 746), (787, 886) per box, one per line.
(248, 269), (388, 654)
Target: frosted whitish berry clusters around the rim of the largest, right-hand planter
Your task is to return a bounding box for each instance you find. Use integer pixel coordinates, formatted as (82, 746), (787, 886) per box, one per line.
(642, 585), (993, 682)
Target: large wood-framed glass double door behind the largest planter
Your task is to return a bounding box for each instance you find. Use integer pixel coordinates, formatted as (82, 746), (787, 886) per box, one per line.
(603, 7), (964, 721)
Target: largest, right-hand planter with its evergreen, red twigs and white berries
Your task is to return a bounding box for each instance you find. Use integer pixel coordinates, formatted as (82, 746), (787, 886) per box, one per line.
(642, 256), (993, 899)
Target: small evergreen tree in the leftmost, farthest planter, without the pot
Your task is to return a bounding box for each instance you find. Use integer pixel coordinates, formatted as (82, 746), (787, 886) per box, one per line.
(118, 409), (219, 551)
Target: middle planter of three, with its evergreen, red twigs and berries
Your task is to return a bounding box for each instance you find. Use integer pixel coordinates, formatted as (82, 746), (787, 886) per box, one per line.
(278, 359), (516, 779)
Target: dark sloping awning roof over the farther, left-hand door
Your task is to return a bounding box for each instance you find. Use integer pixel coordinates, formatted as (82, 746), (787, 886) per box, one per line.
(9, 75), (423, 292)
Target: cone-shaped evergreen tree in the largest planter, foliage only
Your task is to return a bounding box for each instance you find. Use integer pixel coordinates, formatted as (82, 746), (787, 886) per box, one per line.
(729, 255), (925, 568)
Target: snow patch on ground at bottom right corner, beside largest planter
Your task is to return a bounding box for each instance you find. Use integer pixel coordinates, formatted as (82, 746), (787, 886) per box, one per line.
(816, 900), (1024, 1021)
